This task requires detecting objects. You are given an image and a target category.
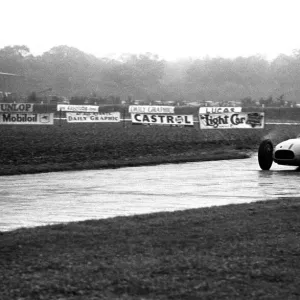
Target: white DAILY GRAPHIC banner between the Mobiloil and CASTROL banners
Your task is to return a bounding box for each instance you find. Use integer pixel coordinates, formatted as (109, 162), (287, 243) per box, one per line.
(66, 111), (121, 123)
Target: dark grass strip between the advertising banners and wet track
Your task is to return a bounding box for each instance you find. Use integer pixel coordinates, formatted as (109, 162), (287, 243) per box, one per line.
(0, 123), (300, 175)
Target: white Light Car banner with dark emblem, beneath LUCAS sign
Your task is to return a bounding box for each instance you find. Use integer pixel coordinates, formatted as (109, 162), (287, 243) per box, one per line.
(199, 112), (265, 129)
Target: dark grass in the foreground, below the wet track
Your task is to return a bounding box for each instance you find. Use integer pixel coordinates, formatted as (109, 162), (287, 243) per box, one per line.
(0, 198), (300, 300)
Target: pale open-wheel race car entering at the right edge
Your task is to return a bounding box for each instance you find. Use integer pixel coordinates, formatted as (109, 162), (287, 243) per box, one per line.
(258, 135), (300, 170)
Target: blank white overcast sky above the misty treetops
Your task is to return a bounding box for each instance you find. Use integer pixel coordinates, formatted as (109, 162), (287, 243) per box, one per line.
(0, 0), (300, 60)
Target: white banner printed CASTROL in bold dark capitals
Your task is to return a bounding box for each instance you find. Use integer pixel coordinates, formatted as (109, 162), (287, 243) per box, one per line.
(131, 114), (194, 126)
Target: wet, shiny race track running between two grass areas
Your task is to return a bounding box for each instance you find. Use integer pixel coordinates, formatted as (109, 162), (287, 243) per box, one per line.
(0, 156), (300, 231)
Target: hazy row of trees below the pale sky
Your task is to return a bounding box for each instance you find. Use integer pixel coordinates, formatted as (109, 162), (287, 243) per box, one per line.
(0, 46), (300, 102)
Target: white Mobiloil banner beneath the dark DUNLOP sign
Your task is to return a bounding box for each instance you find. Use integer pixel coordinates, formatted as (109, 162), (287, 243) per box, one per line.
(0, 113), (54, 125)
